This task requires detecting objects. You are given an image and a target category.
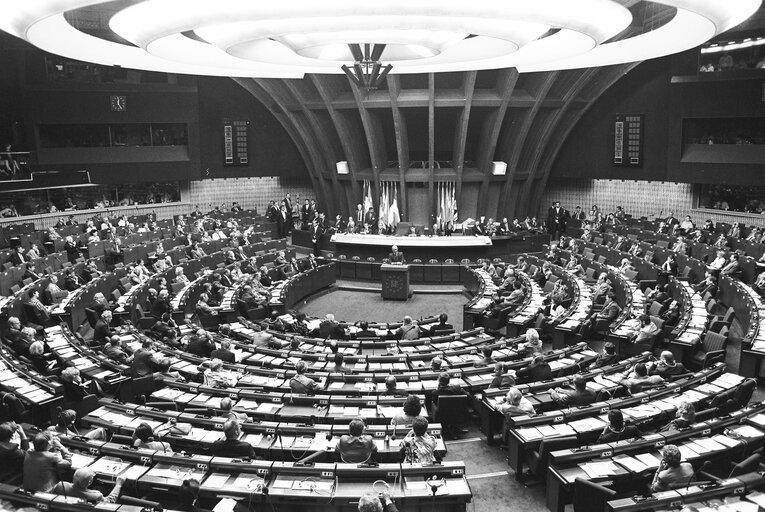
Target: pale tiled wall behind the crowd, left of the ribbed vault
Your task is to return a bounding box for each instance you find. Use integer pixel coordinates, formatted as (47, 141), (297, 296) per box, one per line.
(181, 176), (315, 213)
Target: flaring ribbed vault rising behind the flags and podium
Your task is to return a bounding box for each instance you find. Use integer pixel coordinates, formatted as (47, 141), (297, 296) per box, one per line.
(235, 63), (637, 222)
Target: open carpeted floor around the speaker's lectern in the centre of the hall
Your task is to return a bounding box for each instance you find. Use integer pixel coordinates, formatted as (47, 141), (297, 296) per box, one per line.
(295, 286), (467, 331)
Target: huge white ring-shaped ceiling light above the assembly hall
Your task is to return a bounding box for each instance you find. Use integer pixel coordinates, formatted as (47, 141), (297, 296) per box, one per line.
(0, 0), (761, 78)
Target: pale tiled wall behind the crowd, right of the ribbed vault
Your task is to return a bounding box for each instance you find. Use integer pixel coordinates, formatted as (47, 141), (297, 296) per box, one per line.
(538, 180), (693, 218)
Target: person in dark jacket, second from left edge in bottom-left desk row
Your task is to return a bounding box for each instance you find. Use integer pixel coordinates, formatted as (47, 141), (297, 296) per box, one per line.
(22, 434), (72, 492)
